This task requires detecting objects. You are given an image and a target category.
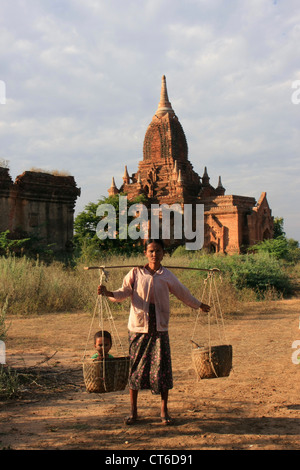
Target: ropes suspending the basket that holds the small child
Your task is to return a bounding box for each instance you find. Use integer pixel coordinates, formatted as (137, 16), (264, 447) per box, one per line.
(82, 266), (125, 392)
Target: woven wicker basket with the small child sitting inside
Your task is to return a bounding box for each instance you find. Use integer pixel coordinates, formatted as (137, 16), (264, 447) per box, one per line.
(83, 356), (130, 393)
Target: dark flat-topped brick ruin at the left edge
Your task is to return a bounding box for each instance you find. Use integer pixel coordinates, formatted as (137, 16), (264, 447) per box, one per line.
(0, 167), (80, 251)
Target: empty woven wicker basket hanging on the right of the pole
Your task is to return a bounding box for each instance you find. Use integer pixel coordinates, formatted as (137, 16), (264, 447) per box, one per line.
(192, 345), (232, 379)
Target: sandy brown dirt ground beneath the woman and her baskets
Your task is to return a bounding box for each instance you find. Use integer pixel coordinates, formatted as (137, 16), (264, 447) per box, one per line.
(0, 299), (300, 451)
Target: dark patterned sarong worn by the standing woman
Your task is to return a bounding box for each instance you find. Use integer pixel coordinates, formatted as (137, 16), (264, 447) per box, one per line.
(129, 304), (173, 394)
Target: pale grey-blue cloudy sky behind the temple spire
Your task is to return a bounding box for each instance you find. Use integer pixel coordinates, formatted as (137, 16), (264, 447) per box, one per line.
(0, 0), (300, 240)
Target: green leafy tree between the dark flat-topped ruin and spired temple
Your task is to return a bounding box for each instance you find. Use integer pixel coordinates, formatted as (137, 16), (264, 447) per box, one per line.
(74, 194), (146, 260)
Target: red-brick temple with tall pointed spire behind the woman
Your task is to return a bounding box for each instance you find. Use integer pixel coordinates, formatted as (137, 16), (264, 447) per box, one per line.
(108, 76), (273, 254)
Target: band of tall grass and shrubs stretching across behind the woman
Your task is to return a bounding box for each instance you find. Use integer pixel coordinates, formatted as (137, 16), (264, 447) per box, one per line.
(0, 250), (299, 318)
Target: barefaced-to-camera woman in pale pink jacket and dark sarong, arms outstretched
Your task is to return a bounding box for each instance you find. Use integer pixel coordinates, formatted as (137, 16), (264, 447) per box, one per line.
(98, 239), (210, 425)
